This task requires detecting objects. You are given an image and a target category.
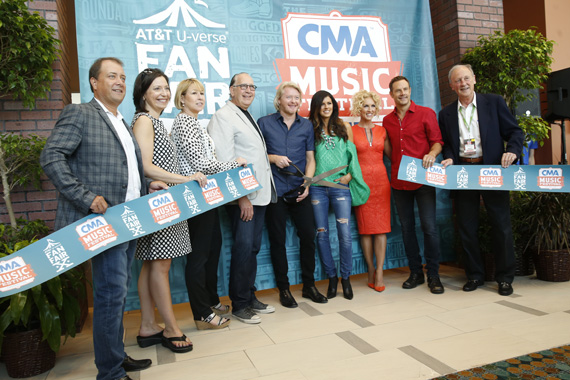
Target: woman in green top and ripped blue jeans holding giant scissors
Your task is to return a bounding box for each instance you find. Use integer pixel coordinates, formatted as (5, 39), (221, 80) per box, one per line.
(309, 91), (365, 300)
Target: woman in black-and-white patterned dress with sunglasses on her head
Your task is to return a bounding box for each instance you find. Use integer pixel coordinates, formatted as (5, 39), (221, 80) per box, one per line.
(132, 69), (206, 353)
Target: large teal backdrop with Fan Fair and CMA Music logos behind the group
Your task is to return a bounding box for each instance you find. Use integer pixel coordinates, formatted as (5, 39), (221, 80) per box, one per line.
(75, 0), (454, 309)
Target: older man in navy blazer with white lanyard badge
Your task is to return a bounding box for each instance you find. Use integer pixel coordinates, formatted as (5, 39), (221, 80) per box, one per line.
(439, 65), (524, 296)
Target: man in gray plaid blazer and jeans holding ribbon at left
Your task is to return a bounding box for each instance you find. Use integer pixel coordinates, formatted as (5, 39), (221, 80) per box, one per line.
(40, 57), (167, 380)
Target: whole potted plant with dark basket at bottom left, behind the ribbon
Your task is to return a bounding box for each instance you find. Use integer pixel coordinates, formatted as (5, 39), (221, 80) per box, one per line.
(0, 219), (86, 377)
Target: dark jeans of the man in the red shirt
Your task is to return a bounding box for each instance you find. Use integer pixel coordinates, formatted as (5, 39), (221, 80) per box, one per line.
(392, 186), (439, 277)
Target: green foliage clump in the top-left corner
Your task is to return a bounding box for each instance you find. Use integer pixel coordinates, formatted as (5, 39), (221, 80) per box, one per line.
(0, 0), (59, 108)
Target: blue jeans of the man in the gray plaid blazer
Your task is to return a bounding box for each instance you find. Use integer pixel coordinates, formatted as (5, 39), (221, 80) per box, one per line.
(91, 240), (137, 380)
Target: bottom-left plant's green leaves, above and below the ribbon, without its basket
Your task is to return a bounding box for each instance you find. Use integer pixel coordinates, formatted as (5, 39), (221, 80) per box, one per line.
(0, 219), (86, 352)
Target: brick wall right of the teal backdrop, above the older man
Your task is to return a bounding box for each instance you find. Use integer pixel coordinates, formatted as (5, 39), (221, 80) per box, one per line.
(430, 0), (505, 106)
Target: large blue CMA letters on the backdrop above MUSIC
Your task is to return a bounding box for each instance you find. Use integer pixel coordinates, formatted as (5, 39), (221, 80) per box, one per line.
(298, 24), (378, 58)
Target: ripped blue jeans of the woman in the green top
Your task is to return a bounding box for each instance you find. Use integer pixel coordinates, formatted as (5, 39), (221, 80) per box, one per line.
(310, 186), (352, 279)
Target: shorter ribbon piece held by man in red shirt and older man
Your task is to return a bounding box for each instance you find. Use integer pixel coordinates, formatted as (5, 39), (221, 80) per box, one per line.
(398, 156), (570, 193)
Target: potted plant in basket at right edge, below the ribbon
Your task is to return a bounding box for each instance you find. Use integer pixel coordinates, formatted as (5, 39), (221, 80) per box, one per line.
(523, 192), (570, 282)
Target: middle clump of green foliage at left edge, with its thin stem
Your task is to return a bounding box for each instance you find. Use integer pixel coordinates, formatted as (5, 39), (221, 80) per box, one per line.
(0, 133), (46, 228)
